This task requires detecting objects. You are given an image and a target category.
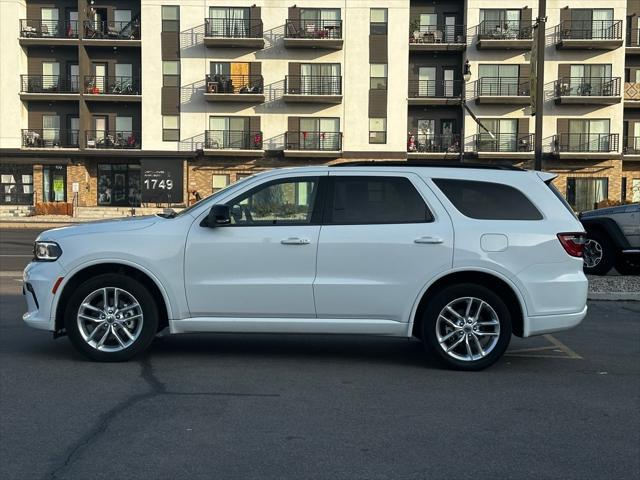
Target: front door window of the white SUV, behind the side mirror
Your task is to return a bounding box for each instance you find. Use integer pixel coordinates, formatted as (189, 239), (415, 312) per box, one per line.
(227, 177), (318, 226)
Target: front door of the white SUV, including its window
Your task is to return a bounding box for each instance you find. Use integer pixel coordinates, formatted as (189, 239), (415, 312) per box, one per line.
(184, 174), (321, 318)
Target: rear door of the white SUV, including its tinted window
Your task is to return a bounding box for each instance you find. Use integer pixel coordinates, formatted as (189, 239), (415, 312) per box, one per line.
(314, 169), (453, 322)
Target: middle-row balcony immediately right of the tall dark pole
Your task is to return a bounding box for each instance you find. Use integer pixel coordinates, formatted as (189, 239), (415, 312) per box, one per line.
(553, 77), (622, 105)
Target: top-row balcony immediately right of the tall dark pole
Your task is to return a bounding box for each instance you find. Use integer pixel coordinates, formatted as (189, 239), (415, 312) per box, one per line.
(554, 20), (622, 50)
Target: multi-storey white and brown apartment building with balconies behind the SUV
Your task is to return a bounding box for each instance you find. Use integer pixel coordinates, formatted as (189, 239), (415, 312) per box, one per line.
(0, 0), (640, 214)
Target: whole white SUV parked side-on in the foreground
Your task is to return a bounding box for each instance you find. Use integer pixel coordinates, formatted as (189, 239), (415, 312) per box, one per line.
(24, 162), (587, 370)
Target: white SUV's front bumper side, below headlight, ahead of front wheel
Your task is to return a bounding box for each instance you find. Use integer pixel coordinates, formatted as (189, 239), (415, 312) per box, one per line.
(22, 262), (65, 331)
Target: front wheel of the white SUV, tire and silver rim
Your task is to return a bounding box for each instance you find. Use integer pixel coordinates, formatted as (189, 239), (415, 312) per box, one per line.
(64, 273), (158, 362)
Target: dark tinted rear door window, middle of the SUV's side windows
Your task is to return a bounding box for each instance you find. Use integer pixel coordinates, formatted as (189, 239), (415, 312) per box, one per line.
(325, 177), (433, 224)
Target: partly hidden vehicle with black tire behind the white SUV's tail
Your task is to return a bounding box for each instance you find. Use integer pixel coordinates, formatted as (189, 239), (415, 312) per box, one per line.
(579, 203), (640, 275)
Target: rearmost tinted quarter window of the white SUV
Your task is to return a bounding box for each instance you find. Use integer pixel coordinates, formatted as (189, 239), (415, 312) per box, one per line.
(433, 178), (542, 220)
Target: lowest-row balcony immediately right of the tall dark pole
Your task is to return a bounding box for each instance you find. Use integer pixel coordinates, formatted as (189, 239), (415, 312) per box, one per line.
(551, 133), (619, 160)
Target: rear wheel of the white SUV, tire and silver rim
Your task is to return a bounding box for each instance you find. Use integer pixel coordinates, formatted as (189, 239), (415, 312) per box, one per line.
(422, 283), (511, 370)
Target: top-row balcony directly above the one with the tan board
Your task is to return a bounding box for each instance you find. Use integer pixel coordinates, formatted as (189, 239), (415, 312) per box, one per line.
(204, 18), (264, 49)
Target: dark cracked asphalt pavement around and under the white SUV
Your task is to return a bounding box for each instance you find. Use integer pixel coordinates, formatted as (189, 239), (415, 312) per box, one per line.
(0, 230), (640, 480)
